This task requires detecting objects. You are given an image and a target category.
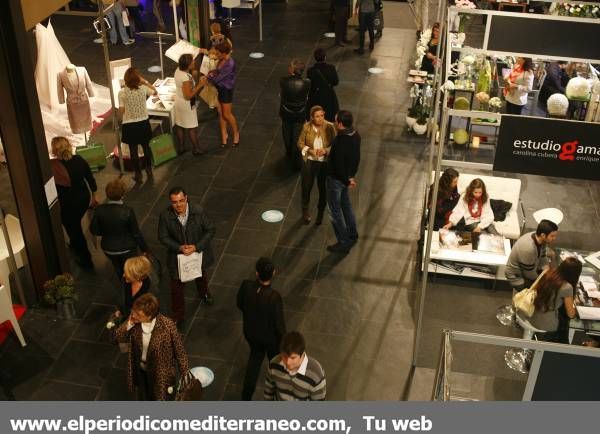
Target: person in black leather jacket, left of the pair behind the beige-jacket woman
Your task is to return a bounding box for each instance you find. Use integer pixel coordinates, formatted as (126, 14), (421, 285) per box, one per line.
(279, 59), (310, 169)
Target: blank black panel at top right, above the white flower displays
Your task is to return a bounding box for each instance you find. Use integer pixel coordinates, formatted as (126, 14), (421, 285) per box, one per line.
(487, 15), (600, 60)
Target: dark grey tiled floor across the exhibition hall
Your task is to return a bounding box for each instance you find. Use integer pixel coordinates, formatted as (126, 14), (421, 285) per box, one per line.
(0, 0), (600, 400)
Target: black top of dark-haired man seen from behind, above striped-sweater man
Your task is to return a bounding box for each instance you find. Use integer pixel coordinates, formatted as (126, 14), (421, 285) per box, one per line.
(237, 280), (285, 347)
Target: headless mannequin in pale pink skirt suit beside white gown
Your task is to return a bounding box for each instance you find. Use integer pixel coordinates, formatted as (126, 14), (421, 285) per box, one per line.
(57, 63), (94, 134)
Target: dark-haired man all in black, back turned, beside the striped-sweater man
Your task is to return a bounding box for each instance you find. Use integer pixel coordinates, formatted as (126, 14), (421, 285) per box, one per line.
(237, 258), (285, 401)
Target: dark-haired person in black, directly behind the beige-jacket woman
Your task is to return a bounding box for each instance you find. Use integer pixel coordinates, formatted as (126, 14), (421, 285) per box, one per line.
(306, 48), (340, 122)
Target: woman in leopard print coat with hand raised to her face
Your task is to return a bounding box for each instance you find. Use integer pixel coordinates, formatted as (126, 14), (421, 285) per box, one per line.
(115, 294), (189, 401)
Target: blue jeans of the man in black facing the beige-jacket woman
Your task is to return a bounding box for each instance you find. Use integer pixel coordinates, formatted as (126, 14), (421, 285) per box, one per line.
(327, 176), (358, 248)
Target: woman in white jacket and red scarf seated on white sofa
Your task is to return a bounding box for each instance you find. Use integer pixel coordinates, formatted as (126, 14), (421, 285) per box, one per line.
(444, 178), (498, 234)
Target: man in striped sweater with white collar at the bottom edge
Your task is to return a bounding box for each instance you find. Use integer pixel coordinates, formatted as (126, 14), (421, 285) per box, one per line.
(265, 332), (326, 401)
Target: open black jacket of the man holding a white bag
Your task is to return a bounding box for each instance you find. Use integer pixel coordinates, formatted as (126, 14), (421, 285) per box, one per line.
(158, 203), (216, 278)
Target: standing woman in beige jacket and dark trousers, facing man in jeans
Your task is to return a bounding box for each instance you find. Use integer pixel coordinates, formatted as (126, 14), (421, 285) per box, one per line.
(298, 105), (336, 226)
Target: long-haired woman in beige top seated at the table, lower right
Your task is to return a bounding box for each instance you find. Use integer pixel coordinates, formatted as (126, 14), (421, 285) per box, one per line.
(529, 257), (581, 343)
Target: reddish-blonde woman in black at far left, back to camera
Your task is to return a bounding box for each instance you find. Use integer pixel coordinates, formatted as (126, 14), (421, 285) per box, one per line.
(50, 136), (98, 268)
